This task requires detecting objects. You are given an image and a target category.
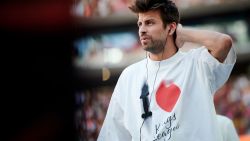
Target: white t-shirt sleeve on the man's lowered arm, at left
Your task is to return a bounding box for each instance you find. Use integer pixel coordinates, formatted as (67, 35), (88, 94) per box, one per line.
(97, 71), (131, 141)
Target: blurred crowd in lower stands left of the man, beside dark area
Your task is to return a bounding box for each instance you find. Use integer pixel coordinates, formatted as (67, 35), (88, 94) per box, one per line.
(75, 87), (113, 141)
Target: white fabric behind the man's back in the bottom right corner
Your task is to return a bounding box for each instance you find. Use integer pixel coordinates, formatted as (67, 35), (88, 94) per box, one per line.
(217, 115), (240, 141)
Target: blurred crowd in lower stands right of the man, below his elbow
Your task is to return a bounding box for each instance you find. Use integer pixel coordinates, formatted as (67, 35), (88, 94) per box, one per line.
(214, 75), (250, 135)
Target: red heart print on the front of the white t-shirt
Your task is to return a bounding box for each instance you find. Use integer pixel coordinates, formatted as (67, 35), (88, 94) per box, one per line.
(156, 81), (181, 112)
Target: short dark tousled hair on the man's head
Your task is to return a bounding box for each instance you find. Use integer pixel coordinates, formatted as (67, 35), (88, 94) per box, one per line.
(129, 0), (180, 27)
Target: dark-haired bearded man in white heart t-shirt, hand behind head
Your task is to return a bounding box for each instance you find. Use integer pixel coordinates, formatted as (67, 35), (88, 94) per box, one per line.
(97, 0), (236, 141)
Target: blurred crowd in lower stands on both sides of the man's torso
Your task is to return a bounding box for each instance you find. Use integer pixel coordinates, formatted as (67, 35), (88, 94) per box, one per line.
(75, 75), (250, 141)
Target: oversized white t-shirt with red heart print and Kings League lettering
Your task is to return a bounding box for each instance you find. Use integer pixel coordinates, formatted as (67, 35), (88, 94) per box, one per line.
(97, 47), (236, 141)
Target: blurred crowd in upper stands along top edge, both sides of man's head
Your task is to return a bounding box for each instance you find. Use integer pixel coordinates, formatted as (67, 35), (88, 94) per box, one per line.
(74, 0), (247, 18)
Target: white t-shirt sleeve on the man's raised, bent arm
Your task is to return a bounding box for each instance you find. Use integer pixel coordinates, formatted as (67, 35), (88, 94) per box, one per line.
(190, 47), (236, 94)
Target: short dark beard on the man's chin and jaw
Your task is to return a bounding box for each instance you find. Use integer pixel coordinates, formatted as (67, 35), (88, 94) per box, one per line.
(143, 39), (166, 54)
